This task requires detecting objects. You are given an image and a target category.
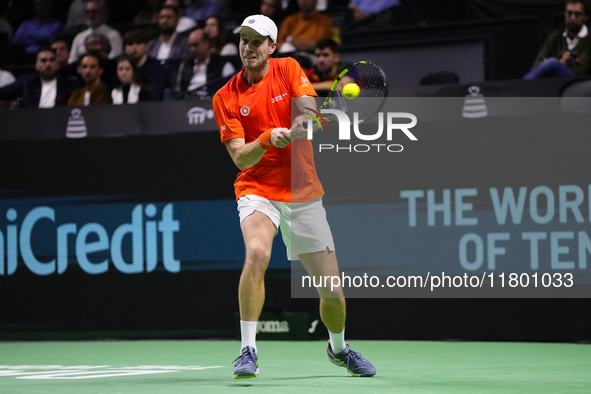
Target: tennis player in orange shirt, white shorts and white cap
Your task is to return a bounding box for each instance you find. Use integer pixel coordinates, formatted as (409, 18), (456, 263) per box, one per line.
(213, 15), (376, 379)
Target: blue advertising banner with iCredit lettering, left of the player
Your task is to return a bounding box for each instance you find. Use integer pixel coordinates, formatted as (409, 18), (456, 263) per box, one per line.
(0, 197), (289, 276)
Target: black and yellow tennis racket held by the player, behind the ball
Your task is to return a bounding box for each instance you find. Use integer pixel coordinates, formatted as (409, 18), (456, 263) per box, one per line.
(307, 61), (388, 127)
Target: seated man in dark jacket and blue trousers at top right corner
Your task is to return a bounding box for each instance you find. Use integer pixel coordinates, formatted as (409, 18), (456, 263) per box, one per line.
(523, 0), (591, 79)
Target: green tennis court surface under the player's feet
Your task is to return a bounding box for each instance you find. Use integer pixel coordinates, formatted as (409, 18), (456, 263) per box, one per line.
(0, 341), (591, 394)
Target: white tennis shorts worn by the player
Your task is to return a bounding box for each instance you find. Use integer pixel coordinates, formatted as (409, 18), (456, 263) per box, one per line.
(238, 194), (335, 261)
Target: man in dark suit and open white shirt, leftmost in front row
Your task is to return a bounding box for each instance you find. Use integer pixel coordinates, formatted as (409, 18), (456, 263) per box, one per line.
(0, 47), (74, 108)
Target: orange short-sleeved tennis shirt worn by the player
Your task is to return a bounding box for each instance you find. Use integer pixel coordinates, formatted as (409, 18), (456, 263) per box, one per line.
(213, 58), (324, 202)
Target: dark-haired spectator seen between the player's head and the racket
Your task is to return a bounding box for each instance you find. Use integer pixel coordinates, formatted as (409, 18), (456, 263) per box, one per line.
(306, 38), (349, 92)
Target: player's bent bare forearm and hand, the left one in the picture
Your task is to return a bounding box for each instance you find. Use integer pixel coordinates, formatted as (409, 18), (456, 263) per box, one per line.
(225, 128), (291, 171)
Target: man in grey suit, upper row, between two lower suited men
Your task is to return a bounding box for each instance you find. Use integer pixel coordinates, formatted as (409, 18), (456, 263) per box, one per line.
(148, 6), (191, 64)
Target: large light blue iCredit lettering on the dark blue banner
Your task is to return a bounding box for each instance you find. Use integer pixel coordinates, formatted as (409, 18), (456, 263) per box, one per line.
(0, 204), (180, 275)
